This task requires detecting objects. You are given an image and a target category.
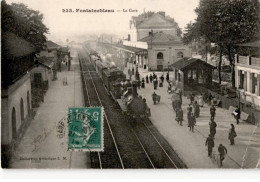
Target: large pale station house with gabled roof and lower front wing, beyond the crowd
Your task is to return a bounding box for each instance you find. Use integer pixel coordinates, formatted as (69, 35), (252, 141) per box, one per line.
(115, 12), (191, 71)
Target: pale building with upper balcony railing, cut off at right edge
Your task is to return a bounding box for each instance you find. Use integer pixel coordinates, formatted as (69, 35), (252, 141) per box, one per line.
(235, 41), (260, 123)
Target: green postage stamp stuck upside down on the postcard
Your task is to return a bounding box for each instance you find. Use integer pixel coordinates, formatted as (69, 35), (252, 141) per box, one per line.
(68, 107), (104, 152)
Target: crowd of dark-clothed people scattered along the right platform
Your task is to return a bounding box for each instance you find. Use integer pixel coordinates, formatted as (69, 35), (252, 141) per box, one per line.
(133, 69), (240, 166)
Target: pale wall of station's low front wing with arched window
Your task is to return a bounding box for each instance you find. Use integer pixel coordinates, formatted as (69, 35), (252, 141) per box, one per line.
(148, 44), (191, 70)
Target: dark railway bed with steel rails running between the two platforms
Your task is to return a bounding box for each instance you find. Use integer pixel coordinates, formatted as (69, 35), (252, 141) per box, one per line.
(76, 45), (186, 169)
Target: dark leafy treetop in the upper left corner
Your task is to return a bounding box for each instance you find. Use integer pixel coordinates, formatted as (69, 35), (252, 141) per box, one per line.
(1, 1), (48, 51)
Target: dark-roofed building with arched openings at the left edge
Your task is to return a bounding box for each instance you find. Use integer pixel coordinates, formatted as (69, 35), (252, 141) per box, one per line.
(1, 32), (36, 149)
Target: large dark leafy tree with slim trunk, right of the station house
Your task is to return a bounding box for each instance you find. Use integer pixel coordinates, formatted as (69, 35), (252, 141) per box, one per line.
(183, 0), (260, 87)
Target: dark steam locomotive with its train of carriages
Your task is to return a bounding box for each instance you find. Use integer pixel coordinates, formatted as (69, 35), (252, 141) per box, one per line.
(87, 47), (151, 119)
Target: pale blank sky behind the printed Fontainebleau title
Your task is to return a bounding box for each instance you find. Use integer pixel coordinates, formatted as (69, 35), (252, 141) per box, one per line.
(6, 0), (199, 39)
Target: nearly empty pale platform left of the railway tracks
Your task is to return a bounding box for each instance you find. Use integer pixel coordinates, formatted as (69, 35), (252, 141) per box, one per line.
(11, 48), (90, 168)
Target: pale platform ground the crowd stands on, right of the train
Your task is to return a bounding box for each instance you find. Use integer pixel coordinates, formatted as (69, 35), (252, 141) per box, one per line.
(128, 64), (260, 169)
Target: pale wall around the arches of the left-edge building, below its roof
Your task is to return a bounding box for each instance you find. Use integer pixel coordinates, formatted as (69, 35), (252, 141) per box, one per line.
(1, 73), (31, 145)
